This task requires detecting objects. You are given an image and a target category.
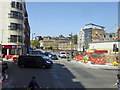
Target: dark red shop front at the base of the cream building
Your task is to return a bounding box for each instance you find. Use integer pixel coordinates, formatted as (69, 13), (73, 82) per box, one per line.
(2, 45), (22, 55)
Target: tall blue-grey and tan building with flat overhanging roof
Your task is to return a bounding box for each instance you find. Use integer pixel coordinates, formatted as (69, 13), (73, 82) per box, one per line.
(83, 23), (105, 44)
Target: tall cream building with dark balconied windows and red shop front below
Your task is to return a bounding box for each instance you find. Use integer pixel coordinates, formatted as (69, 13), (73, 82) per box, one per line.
(0, 0), (30, 55)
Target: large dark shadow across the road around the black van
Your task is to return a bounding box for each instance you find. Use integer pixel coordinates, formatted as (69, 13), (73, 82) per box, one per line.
(2, 63), (86, 90)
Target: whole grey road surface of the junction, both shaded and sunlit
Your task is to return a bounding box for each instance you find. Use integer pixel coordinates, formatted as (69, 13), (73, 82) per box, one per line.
(3, 60), (117, 88)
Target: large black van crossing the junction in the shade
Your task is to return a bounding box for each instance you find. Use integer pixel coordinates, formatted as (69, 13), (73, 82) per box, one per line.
(18, 55), (53, 68)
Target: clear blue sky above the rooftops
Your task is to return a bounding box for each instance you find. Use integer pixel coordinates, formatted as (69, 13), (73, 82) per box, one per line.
(26, 2), (118, 36)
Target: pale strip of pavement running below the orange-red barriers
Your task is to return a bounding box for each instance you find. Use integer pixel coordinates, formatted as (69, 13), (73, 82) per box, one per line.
(71, 60), (120, 70)
